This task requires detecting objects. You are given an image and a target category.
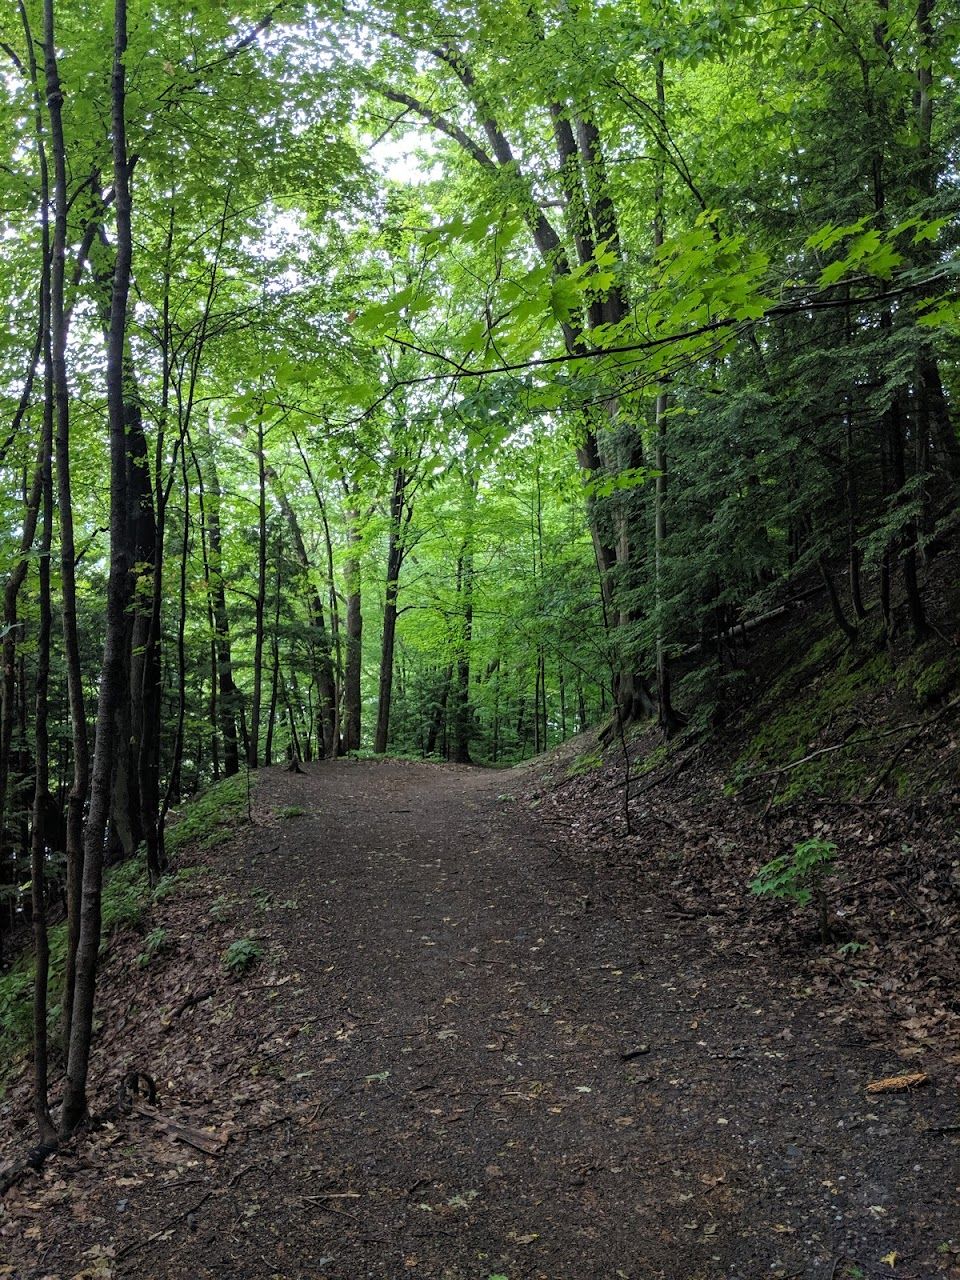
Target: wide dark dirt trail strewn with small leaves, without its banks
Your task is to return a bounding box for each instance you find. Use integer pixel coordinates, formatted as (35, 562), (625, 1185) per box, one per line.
(11, 762), (960, 1280)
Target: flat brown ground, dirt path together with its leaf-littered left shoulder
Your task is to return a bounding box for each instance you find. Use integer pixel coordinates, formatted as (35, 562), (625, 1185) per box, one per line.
(0, 760), (960, 1280)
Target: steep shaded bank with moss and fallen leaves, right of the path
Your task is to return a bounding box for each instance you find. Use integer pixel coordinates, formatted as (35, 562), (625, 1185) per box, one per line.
(535, 549), (960, 1071)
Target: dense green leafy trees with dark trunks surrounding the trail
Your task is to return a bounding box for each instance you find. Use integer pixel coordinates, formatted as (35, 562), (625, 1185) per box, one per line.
(0, 0), (960, 1162)
